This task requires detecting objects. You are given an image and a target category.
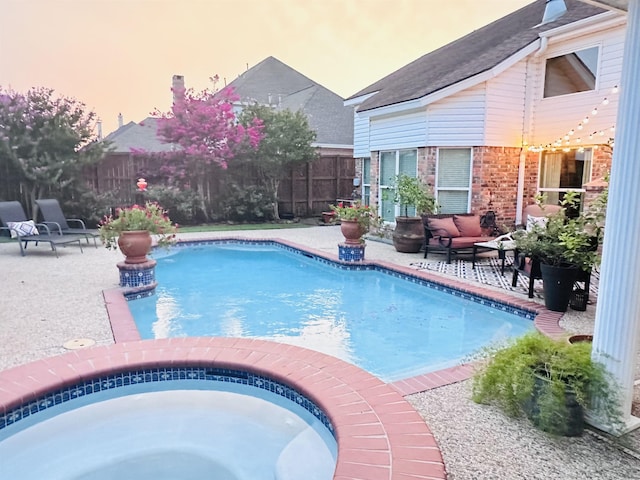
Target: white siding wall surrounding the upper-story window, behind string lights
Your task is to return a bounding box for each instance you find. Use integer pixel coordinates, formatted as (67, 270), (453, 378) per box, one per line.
(529, 27), (624, 145)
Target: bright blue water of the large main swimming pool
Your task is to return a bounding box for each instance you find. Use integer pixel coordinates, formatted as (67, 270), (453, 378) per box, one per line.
(129, 243), (534, 381)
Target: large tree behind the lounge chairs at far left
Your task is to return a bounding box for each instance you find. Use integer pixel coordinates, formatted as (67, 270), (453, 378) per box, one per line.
(0, 87), (107, 218)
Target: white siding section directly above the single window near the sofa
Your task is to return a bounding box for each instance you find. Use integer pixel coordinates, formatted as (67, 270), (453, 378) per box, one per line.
(427, 83), (486, 147)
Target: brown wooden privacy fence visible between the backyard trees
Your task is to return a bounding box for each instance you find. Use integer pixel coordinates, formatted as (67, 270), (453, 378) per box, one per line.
(84, 152), (356, 217)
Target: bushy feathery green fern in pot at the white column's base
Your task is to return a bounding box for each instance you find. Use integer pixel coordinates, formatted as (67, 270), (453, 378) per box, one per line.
(472, 332), (620, 436)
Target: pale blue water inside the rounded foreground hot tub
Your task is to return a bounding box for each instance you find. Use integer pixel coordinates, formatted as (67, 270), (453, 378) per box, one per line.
(0, 382), (337, 480)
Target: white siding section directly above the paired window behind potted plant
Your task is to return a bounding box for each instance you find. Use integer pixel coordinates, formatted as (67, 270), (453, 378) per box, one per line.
(370, 111), (426, 151)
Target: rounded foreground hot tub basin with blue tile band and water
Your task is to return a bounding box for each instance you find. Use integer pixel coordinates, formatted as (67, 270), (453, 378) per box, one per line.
(0, 367), (337, 480)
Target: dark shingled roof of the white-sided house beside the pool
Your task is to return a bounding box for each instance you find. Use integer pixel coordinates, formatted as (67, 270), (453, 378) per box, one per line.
(347, 0), (606, 111)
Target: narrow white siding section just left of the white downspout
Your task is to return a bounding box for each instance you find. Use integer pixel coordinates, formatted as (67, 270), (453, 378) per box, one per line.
(488, 60), (527, 147)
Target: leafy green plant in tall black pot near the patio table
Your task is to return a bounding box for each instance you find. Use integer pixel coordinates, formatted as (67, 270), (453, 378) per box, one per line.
(514, 192), (603, 312)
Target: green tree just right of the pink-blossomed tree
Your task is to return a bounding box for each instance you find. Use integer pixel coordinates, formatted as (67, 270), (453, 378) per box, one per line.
(238, 104), (318, 219)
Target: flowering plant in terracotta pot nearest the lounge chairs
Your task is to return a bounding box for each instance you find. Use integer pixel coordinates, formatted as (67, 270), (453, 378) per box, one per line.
(99, 202), (178, 263)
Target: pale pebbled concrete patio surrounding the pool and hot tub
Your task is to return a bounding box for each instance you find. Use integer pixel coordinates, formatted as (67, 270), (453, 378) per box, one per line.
(0, 226), (640, 480)
